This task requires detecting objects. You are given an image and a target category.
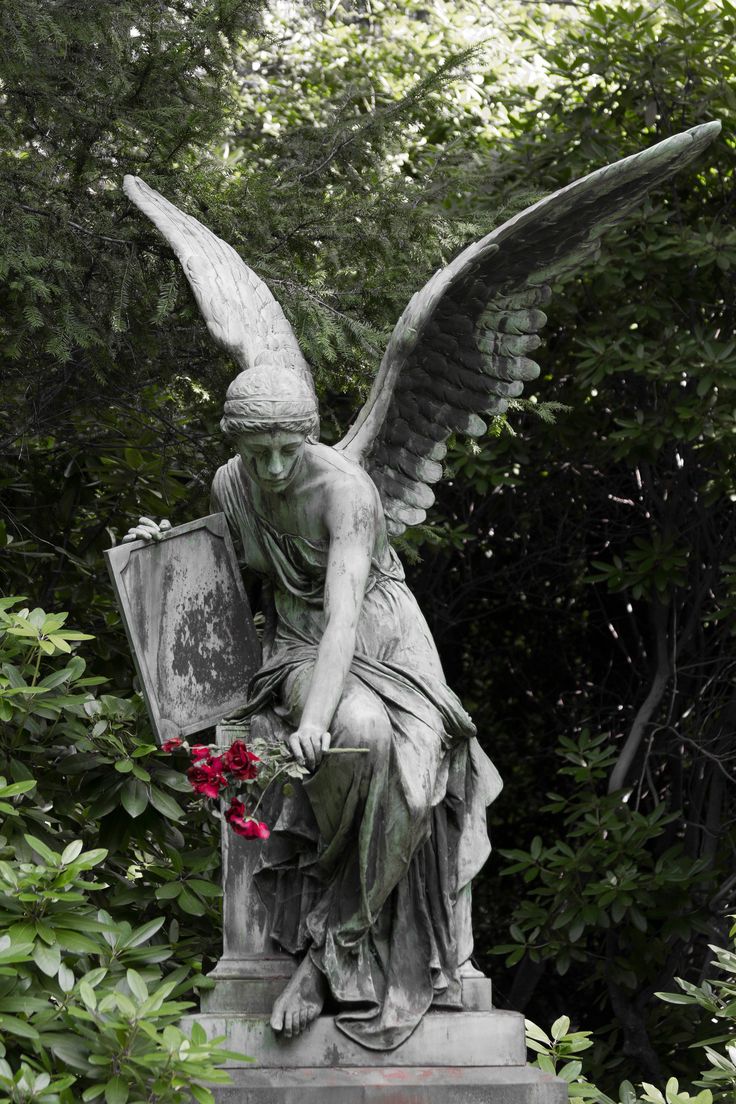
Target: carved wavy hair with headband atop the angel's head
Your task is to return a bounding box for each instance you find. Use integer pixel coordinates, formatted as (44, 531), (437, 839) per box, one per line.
(220, 368), (319, 437)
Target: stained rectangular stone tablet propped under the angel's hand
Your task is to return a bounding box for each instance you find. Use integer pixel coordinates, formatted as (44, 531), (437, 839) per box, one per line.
(105, 513), (260, 741)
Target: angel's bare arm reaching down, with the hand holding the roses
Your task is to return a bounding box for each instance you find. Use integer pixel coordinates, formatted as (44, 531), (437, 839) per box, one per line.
(289, 480), (377, 766)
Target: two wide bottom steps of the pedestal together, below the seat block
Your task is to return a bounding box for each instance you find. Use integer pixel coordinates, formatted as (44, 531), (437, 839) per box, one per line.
(182, 1011), (567, 1104)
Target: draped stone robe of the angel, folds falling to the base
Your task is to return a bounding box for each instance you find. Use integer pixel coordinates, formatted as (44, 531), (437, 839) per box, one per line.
(213, 457), (501, 1050)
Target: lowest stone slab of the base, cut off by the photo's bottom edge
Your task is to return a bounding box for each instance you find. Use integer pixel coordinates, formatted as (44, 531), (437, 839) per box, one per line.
(206, 1065), (567, 1104)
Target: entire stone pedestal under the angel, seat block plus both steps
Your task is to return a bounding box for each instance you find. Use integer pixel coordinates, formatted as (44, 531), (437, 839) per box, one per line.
(188, 725), (567, 1104)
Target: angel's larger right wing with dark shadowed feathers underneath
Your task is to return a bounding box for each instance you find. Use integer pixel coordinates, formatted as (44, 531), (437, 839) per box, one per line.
(337, 123), (721, 534)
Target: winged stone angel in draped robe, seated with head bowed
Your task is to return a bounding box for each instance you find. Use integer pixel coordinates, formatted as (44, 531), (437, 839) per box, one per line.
(124, 123), (719, 1050)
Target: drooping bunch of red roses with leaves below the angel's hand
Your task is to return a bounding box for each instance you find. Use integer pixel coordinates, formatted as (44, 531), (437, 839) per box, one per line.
(161, 736), (309, 839)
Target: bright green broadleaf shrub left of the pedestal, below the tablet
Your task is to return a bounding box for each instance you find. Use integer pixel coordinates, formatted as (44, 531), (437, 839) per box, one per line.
(0, 598), (240, 1104)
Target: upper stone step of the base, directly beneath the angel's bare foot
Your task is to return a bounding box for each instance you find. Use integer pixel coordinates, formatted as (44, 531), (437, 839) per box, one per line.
(182, 1011), (526, 1072)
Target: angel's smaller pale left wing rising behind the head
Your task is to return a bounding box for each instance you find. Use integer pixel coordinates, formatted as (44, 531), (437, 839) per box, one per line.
(122, 177), (314, 392)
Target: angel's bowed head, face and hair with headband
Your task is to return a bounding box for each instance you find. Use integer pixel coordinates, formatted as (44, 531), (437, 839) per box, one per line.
(220, 368), (319, 493)
